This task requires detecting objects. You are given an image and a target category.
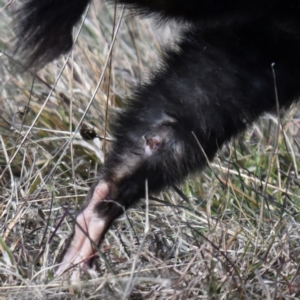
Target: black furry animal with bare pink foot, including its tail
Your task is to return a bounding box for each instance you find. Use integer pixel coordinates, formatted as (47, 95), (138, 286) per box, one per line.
(19, 0), (300, 273)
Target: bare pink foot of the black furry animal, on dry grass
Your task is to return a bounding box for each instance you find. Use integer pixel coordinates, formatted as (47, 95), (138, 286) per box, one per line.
(56, 182), (115, 281)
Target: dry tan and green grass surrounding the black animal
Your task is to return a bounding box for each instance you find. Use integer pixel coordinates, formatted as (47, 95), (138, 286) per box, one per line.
(0, 0), (300, 300)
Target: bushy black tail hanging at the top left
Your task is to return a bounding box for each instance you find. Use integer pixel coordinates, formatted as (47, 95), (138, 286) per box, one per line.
(16, 0), (91, 68)
